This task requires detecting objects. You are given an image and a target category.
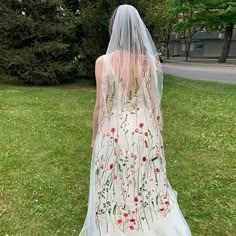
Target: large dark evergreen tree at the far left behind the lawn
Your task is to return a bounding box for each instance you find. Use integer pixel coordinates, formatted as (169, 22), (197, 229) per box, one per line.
(0, 0), (75, 84)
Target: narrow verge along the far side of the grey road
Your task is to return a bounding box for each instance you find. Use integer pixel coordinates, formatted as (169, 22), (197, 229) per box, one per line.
(164, 57), (236, 67)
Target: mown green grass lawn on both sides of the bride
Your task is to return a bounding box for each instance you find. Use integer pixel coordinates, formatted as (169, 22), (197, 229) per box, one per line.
(0, 75), (236, 236)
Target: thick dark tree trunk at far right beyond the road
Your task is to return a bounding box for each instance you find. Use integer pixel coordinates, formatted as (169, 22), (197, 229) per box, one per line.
(218, 24), (234, 63)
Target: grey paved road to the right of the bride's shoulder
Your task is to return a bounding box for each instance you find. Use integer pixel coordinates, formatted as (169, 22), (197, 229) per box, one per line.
(162, 62), (236, 83)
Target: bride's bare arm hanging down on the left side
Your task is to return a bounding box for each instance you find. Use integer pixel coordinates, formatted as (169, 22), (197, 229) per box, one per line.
(91, 56), (103, 148)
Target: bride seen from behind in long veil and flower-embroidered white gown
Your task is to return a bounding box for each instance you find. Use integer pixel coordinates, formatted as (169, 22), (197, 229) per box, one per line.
(79, 5), (191, 236)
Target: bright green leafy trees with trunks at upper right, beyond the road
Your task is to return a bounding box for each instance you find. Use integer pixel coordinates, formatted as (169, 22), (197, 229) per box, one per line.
(168, 0), (236, 62)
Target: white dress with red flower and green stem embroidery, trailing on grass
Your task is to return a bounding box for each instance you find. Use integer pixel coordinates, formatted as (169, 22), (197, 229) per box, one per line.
(79, 53), (191, 236)
